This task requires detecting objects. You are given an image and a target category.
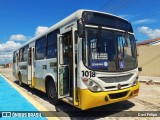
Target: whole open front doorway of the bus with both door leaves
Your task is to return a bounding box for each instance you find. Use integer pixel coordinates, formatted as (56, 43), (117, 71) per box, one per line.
(57, 28), (78, 105)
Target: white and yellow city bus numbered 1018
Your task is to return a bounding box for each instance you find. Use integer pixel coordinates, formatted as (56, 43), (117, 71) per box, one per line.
(13, 10), (139, 110)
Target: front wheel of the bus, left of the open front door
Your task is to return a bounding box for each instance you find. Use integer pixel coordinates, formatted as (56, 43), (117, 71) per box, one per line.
(46, 80), (59, 105)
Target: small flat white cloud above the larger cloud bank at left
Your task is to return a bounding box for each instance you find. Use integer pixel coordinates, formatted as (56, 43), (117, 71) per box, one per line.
(9, 34), (30, 41)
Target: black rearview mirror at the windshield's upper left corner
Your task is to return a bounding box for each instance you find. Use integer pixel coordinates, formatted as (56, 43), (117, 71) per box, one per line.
(77, 18), (85, 38)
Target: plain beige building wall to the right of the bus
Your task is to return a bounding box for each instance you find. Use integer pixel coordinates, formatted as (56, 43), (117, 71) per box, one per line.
(137, 45), (160, 77)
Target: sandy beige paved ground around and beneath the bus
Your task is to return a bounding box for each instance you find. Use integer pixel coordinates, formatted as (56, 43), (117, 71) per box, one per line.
(0, 68), (160, 120)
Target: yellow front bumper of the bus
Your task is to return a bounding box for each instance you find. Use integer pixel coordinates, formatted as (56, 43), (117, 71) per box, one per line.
(79, 82), (140, 110)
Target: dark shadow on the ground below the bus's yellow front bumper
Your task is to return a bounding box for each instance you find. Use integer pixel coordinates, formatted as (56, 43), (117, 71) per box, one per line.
(53, 100), (135, 120)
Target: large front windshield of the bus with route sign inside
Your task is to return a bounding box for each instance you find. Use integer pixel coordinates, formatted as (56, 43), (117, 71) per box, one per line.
(83, 28), (137, 71)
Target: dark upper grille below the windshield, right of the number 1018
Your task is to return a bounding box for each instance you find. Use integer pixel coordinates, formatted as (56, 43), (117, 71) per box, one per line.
(99, 74), (133, 83)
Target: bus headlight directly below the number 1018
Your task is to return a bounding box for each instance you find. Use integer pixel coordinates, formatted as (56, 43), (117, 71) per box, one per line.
(82, 78), (103, 91)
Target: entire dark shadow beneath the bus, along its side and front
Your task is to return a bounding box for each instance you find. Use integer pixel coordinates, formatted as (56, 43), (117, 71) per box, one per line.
(14, 81), (135, 120)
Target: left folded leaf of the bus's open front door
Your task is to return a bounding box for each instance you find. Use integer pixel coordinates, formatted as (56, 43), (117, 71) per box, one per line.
(57, 35), (70, 98)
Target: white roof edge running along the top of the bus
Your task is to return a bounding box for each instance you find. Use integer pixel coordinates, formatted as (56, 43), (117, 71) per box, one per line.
(14, 9), (129, 51)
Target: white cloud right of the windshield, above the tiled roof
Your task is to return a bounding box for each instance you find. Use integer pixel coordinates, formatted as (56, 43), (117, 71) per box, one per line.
(138, 26), (160, 39)
